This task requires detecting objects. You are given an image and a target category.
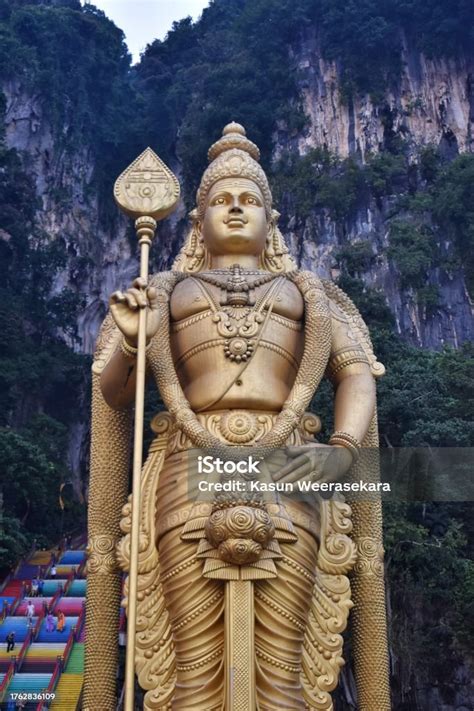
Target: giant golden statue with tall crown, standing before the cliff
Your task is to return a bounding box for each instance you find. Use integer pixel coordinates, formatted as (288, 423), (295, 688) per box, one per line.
(83, 123), (390, 711)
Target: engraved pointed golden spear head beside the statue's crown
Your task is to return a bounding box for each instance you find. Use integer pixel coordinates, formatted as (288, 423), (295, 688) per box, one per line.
(114, 148), (180, 220)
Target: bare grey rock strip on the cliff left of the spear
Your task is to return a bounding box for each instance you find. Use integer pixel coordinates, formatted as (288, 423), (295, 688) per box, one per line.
(3, 83), (137, 353)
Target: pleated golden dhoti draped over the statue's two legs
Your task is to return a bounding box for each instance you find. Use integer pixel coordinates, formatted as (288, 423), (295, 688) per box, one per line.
(156, 436), (319, 711)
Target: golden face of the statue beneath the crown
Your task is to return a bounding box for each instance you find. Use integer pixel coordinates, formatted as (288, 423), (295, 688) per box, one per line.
(202, 178), (268, 256)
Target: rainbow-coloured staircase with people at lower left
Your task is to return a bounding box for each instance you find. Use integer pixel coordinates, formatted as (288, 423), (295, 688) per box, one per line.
(0, 542), (86, 711)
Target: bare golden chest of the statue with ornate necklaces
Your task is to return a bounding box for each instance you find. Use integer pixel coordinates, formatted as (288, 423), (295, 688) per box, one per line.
(171, 279), (304, 378)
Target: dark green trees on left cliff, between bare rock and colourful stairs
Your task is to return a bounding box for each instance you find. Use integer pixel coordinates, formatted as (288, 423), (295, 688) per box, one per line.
(0, 90), (87, 566)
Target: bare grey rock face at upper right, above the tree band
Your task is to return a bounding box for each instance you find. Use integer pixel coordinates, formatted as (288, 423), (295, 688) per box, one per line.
(295, 31), (474, 160)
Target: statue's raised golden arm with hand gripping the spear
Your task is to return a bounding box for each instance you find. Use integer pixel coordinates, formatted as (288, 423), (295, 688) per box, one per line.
(100, 279), (159, 410)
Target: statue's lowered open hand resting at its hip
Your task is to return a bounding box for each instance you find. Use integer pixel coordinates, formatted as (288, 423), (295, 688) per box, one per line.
(273, 444), (352, 483)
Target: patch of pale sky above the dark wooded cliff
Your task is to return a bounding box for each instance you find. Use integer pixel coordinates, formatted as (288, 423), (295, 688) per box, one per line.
(83, 0), (209, 62)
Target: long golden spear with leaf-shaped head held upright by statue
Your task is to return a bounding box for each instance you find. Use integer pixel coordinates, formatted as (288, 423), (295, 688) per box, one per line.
(114, 148), (180, 711)
